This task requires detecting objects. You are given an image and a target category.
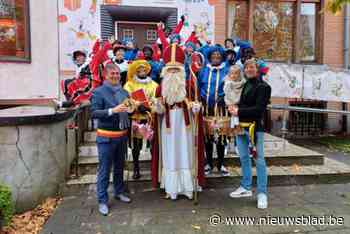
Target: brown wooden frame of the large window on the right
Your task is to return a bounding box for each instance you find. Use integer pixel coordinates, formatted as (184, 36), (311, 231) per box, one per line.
(226, 0), (325, 64)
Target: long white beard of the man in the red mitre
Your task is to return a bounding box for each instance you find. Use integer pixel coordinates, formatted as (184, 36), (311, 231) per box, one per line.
(162, 70), (186, 105)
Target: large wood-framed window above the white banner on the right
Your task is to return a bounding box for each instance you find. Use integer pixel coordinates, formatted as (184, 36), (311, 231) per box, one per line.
(227, 0), (321, 62)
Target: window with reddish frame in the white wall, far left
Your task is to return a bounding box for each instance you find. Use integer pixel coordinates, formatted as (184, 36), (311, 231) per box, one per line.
(0, 0), (30, 62)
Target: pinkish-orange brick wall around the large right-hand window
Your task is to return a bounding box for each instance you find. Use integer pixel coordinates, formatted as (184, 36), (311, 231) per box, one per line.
(215, 0), (350, 132)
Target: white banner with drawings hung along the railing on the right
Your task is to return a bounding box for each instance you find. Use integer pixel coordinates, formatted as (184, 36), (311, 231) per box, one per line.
(266, 63), (350, 102)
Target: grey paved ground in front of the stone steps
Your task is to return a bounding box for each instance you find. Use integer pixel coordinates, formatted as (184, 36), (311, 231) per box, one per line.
(42, 140), (350, 234)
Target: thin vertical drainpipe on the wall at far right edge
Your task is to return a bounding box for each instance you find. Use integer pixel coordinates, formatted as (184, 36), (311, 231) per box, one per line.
(342, 3), (350, 133)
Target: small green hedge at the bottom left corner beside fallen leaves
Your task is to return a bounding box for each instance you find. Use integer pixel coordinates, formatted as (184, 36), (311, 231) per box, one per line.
(0, 184), (14, 226)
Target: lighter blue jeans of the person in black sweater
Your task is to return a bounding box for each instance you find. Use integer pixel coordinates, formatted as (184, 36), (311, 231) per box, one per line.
(236, 132), (267, 194)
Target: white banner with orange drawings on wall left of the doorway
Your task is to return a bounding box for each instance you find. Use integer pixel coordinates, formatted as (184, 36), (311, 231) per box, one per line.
(58, 0), (102, 71)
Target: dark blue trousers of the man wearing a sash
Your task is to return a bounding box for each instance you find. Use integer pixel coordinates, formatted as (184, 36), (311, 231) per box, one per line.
(96, 136), (128, 204)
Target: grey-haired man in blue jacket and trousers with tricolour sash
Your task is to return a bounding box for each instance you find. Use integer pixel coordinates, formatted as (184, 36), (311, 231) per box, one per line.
(91, 63), (131, 215)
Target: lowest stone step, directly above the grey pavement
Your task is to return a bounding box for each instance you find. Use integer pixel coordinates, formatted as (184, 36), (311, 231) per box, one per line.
(61, 158), (350, 193)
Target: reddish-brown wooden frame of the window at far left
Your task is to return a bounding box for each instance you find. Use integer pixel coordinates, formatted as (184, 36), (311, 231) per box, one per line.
(0, 0), (32, 63)
